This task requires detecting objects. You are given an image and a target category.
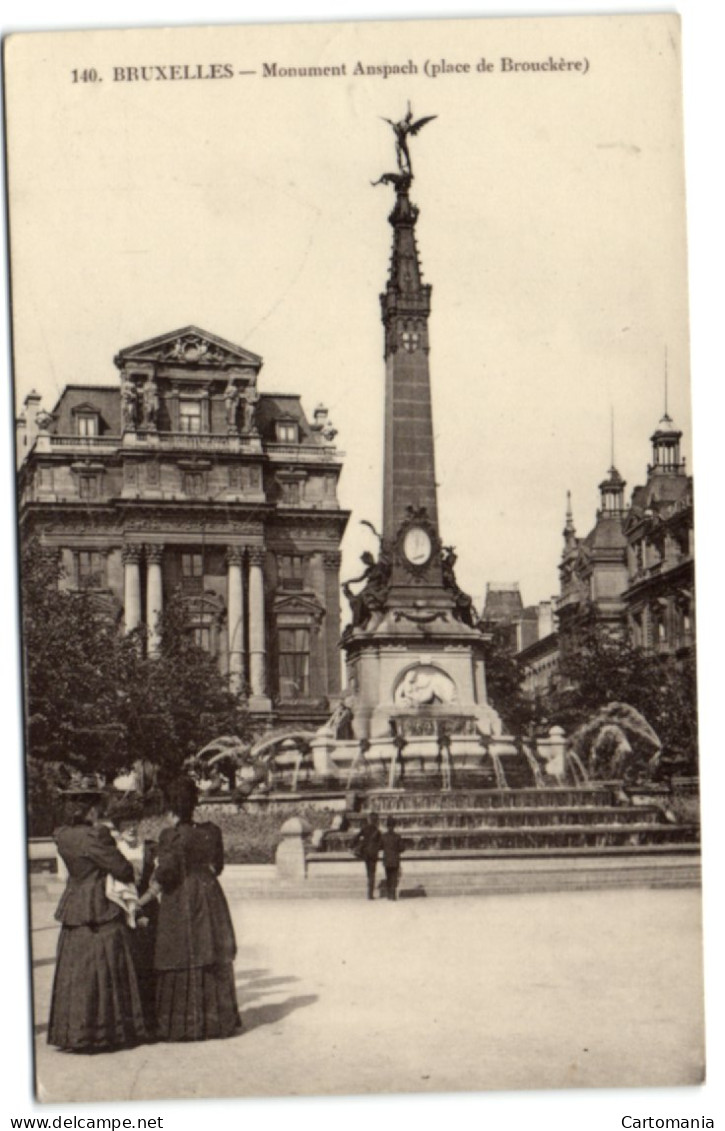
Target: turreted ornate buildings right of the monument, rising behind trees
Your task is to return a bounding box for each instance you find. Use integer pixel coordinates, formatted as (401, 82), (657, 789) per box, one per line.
(511, 402), (694, 697)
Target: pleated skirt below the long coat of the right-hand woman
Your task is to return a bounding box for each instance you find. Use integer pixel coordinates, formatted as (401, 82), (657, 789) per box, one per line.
(156, 962), (242, 1041)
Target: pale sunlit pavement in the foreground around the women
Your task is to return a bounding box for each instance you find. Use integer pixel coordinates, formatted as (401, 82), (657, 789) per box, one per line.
(32, 875), (704, 1103)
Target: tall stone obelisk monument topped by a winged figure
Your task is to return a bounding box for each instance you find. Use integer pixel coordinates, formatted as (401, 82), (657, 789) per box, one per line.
(313, 112), (507, 785)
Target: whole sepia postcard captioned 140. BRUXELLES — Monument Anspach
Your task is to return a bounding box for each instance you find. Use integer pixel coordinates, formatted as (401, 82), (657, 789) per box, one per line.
(5, 15), (714, 1112)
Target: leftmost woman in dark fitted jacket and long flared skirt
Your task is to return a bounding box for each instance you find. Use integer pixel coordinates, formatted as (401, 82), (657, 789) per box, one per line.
(48, 797), (147, 1053)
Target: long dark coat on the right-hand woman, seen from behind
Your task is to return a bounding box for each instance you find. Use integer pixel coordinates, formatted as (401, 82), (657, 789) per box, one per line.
(154, 822), (236, 970)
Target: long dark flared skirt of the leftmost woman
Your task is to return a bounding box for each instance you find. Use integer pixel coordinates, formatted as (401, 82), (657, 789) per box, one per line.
(48, 918), (147, 1053)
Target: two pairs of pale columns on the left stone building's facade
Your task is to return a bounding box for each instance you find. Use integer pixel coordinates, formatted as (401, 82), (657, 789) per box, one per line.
(123, 543), (267, 698)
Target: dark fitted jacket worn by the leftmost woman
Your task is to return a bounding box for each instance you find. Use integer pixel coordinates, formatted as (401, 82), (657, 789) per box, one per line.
(55, 824), (133, 926)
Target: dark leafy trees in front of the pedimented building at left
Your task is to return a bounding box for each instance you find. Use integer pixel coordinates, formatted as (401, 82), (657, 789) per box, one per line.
(21, 543), (254, 793)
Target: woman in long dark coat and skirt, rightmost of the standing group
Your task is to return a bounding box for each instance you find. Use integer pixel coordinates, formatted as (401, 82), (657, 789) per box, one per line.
(154, 778), (241, 1041)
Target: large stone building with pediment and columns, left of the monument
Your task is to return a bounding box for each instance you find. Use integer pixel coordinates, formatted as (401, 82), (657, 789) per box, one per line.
(18, 327), (348, 724)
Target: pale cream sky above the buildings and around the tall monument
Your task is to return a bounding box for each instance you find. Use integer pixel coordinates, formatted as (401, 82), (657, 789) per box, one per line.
(8, 17), (692, 604)
